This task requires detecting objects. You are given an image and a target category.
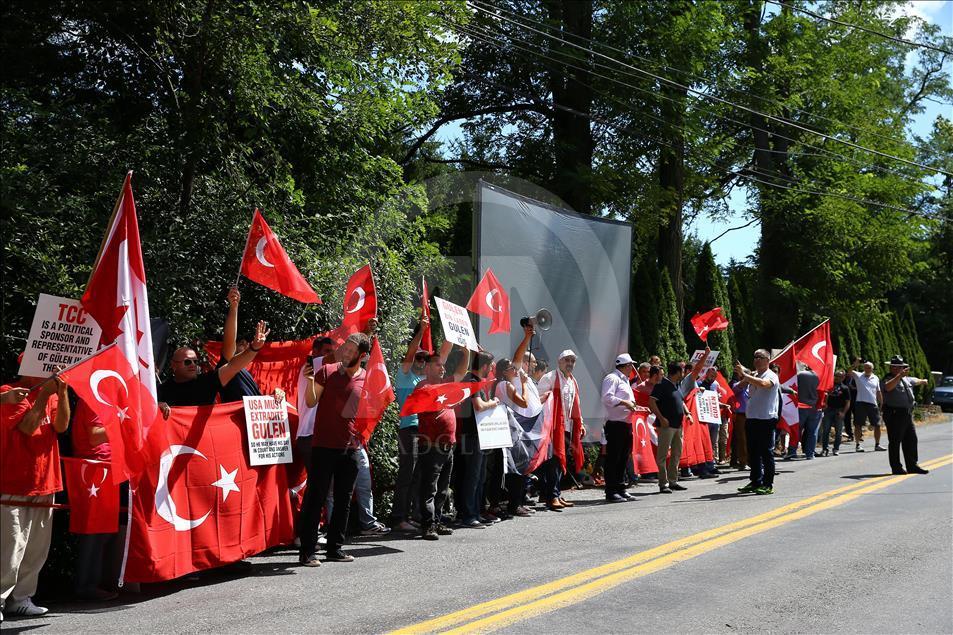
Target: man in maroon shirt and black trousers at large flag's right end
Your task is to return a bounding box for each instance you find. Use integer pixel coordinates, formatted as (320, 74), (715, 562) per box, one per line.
(298, 333), (371, 567)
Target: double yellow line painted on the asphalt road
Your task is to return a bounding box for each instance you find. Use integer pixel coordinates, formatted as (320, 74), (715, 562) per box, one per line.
(394, 454), (953, 634)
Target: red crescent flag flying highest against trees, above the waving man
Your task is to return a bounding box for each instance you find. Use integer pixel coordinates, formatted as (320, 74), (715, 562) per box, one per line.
(242, 209), (321, 304)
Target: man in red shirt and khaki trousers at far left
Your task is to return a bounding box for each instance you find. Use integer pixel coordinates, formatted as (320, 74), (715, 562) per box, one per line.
(0, 375), (70, 616)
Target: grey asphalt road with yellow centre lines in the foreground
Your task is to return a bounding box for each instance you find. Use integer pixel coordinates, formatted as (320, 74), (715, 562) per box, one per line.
(3, 417), (953, 633)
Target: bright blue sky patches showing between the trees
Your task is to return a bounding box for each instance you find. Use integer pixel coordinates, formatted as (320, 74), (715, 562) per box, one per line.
(436, 0), (953, 265)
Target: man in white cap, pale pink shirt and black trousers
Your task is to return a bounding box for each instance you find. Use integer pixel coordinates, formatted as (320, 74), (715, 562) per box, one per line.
(602, 353), (636, 503)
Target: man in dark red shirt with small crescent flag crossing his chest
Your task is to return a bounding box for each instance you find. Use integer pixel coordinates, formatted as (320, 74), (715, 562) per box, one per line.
(415, 349), (470, 540)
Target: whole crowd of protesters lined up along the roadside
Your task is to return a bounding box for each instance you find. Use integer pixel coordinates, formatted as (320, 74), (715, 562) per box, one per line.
(0, 289), (926, 616)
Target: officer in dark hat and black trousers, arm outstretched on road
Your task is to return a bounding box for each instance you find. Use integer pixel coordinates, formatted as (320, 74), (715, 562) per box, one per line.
(883, 355), (929, 474)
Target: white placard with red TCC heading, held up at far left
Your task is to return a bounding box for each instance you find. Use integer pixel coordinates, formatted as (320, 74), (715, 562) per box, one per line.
(20, 293), (103, 377)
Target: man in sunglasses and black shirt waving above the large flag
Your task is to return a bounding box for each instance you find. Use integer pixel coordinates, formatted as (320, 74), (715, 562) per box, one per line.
(159, 322), (270, 419)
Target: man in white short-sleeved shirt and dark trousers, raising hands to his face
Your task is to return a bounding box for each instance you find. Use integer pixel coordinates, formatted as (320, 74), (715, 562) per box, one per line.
(735, 348), (781, 494)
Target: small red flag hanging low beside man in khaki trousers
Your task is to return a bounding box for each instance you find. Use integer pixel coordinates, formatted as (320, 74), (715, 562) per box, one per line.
(63, 457), (119, 534)
